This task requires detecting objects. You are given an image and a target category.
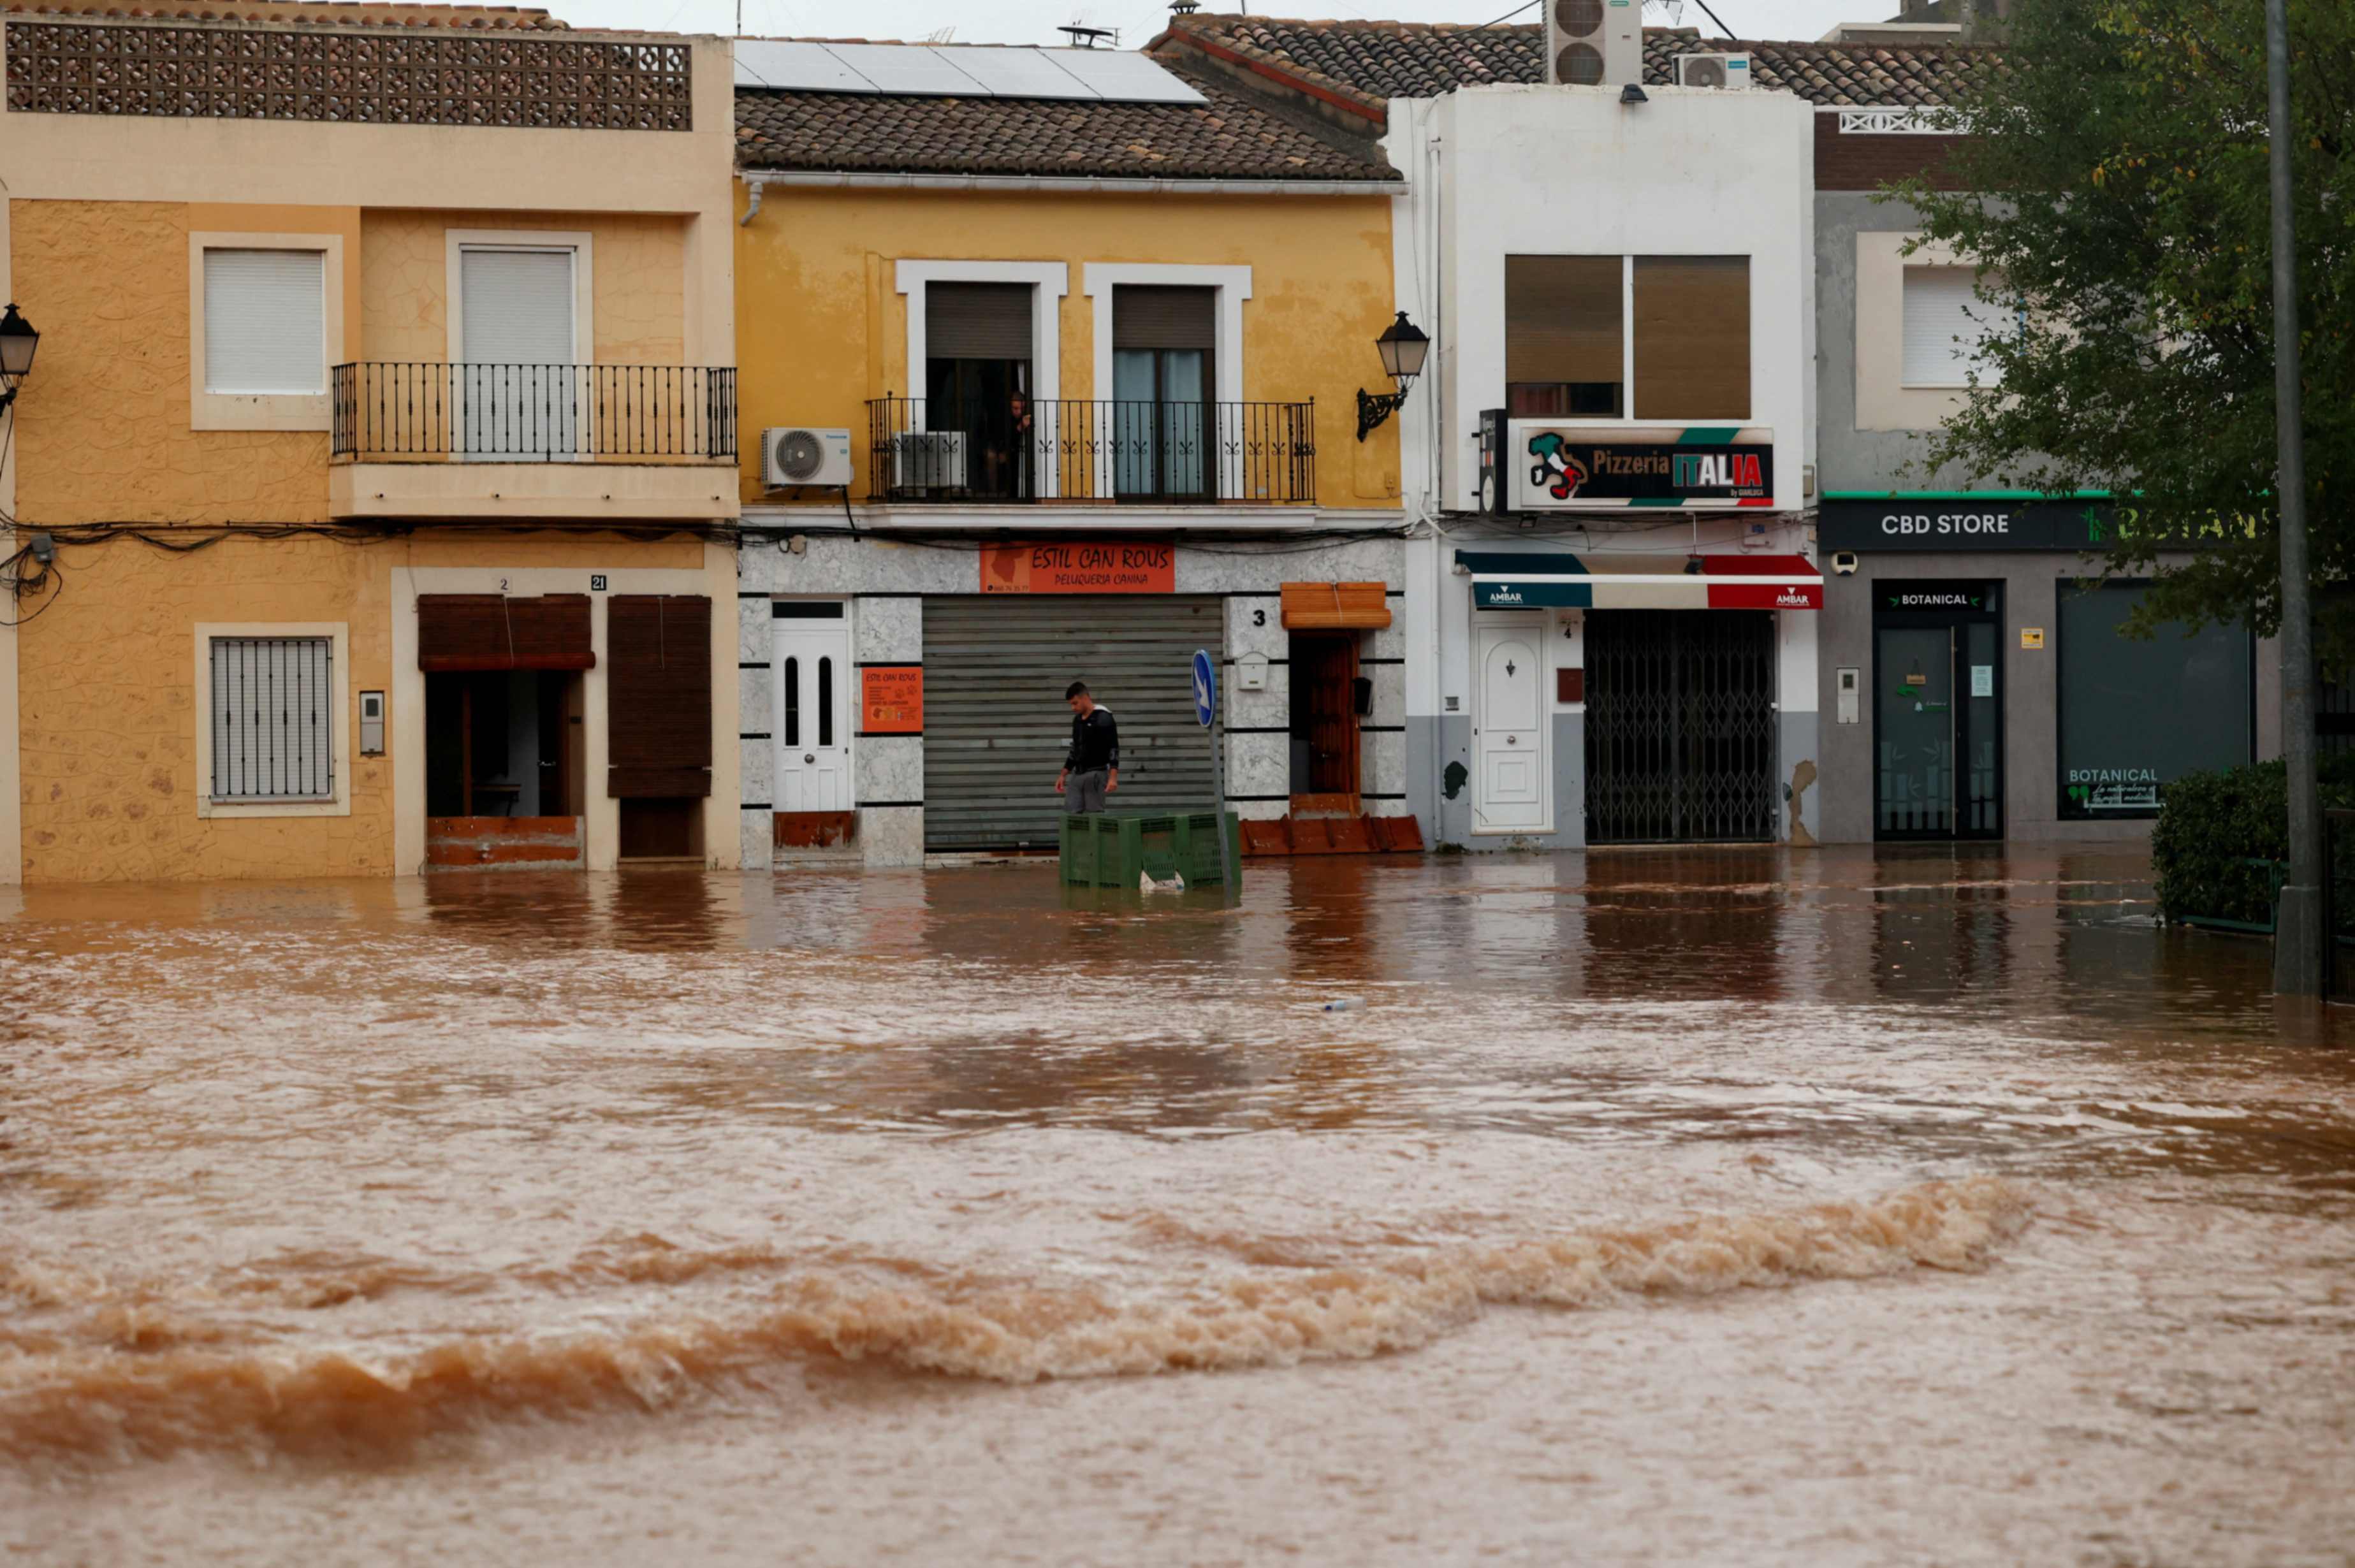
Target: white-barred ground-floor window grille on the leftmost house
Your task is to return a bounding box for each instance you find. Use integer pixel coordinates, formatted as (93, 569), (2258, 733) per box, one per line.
(212, 638), (335, 801)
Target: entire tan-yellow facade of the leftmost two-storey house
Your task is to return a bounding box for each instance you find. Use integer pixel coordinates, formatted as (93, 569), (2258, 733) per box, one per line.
(0, 4), (740, 880)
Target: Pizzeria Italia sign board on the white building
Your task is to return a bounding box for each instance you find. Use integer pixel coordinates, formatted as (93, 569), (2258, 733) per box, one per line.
(1503, 419), (1774, 511)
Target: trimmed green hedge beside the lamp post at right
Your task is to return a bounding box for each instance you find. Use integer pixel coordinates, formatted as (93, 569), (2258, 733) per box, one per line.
(2150, 756), (2355, 926)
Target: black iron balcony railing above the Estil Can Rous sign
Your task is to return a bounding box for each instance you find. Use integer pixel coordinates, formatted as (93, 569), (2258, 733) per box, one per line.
(866, 398), (1316, 506)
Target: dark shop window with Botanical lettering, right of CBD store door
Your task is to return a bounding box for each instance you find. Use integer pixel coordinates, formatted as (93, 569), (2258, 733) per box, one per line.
(2059, 581), (2256, 822)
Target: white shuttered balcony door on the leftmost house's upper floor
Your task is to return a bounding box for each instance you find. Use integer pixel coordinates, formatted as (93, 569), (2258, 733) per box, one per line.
(452, 247), (587, 461)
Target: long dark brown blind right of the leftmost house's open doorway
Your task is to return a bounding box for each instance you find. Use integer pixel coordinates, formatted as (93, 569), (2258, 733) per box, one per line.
(605, 593), (711, 801)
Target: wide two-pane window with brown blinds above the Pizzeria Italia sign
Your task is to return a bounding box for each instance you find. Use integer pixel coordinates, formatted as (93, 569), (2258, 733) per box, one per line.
(1505, 257), (1750, 419)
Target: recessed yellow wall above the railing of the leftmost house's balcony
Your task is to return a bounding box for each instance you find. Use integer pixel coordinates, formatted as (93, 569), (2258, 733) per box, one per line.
(356, 210), (688, 365)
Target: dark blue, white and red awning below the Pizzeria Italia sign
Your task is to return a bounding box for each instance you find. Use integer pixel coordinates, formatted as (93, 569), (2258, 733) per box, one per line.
(1455, 551), (1823, 610)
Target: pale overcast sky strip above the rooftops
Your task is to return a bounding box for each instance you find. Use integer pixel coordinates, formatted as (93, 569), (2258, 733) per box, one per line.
(565, 0), (1898, 47)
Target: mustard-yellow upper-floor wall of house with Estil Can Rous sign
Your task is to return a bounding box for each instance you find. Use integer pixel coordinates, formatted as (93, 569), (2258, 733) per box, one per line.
(735, 186), (1399, 506)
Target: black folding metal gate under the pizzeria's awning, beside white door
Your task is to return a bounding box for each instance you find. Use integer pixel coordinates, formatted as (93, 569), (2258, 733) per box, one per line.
(1587, 610), (1778, 843)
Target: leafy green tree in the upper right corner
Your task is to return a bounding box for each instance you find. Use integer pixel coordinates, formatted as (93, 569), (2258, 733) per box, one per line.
(1893, 0), (2355, 650)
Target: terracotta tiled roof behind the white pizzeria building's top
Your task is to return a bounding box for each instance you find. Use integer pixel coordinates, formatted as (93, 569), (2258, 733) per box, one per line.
(1156, 14), (2002, 111)
